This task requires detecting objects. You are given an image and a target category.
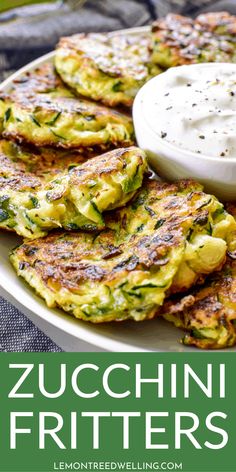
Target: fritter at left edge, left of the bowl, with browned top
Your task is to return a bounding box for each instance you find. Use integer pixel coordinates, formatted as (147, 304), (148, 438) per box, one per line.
(0, 64), (133, 149)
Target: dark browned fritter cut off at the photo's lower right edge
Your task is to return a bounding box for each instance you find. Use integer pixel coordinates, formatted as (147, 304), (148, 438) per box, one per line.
(160, 258), (236, 349)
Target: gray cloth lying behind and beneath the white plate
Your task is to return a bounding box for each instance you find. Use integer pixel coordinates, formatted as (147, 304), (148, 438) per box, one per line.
(0, 0), (236, 352)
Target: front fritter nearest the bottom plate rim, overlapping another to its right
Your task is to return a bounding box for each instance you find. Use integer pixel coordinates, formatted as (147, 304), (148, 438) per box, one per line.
(10, 230), (183, 323)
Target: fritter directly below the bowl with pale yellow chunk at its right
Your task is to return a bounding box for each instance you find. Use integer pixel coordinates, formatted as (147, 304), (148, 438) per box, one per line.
(106, 180), (236, 293)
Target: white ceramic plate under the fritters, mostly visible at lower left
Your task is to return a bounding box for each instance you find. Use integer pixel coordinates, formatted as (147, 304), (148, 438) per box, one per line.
(0, 27), (232, 352)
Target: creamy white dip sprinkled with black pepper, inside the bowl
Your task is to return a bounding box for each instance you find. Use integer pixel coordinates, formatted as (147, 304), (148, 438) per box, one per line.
(147, 64), (236, 159)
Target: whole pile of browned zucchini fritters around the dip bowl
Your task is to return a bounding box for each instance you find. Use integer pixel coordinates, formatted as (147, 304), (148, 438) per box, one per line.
(0, 17), (236, 348)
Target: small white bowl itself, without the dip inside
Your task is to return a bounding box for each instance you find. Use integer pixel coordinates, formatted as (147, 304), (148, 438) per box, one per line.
(133, 64), (236, 201)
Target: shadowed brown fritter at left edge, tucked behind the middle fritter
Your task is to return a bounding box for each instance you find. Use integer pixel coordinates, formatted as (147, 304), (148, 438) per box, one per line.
(0, 139), (90, 232)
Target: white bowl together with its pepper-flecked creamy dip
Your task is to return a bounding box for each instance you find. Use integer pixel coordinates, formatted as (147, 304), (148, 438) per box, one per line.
(133, 63), (236, 200)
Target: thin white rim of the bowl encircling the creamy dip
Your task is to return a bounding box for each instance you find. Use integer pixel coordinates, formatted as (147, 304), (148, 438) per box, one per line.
(133, 62), (236, 165)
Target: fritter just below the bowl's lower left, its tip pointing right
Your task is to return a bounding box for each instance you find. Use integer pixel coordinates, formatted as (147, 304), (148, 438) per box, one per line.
(0, 142), (147, 239)
